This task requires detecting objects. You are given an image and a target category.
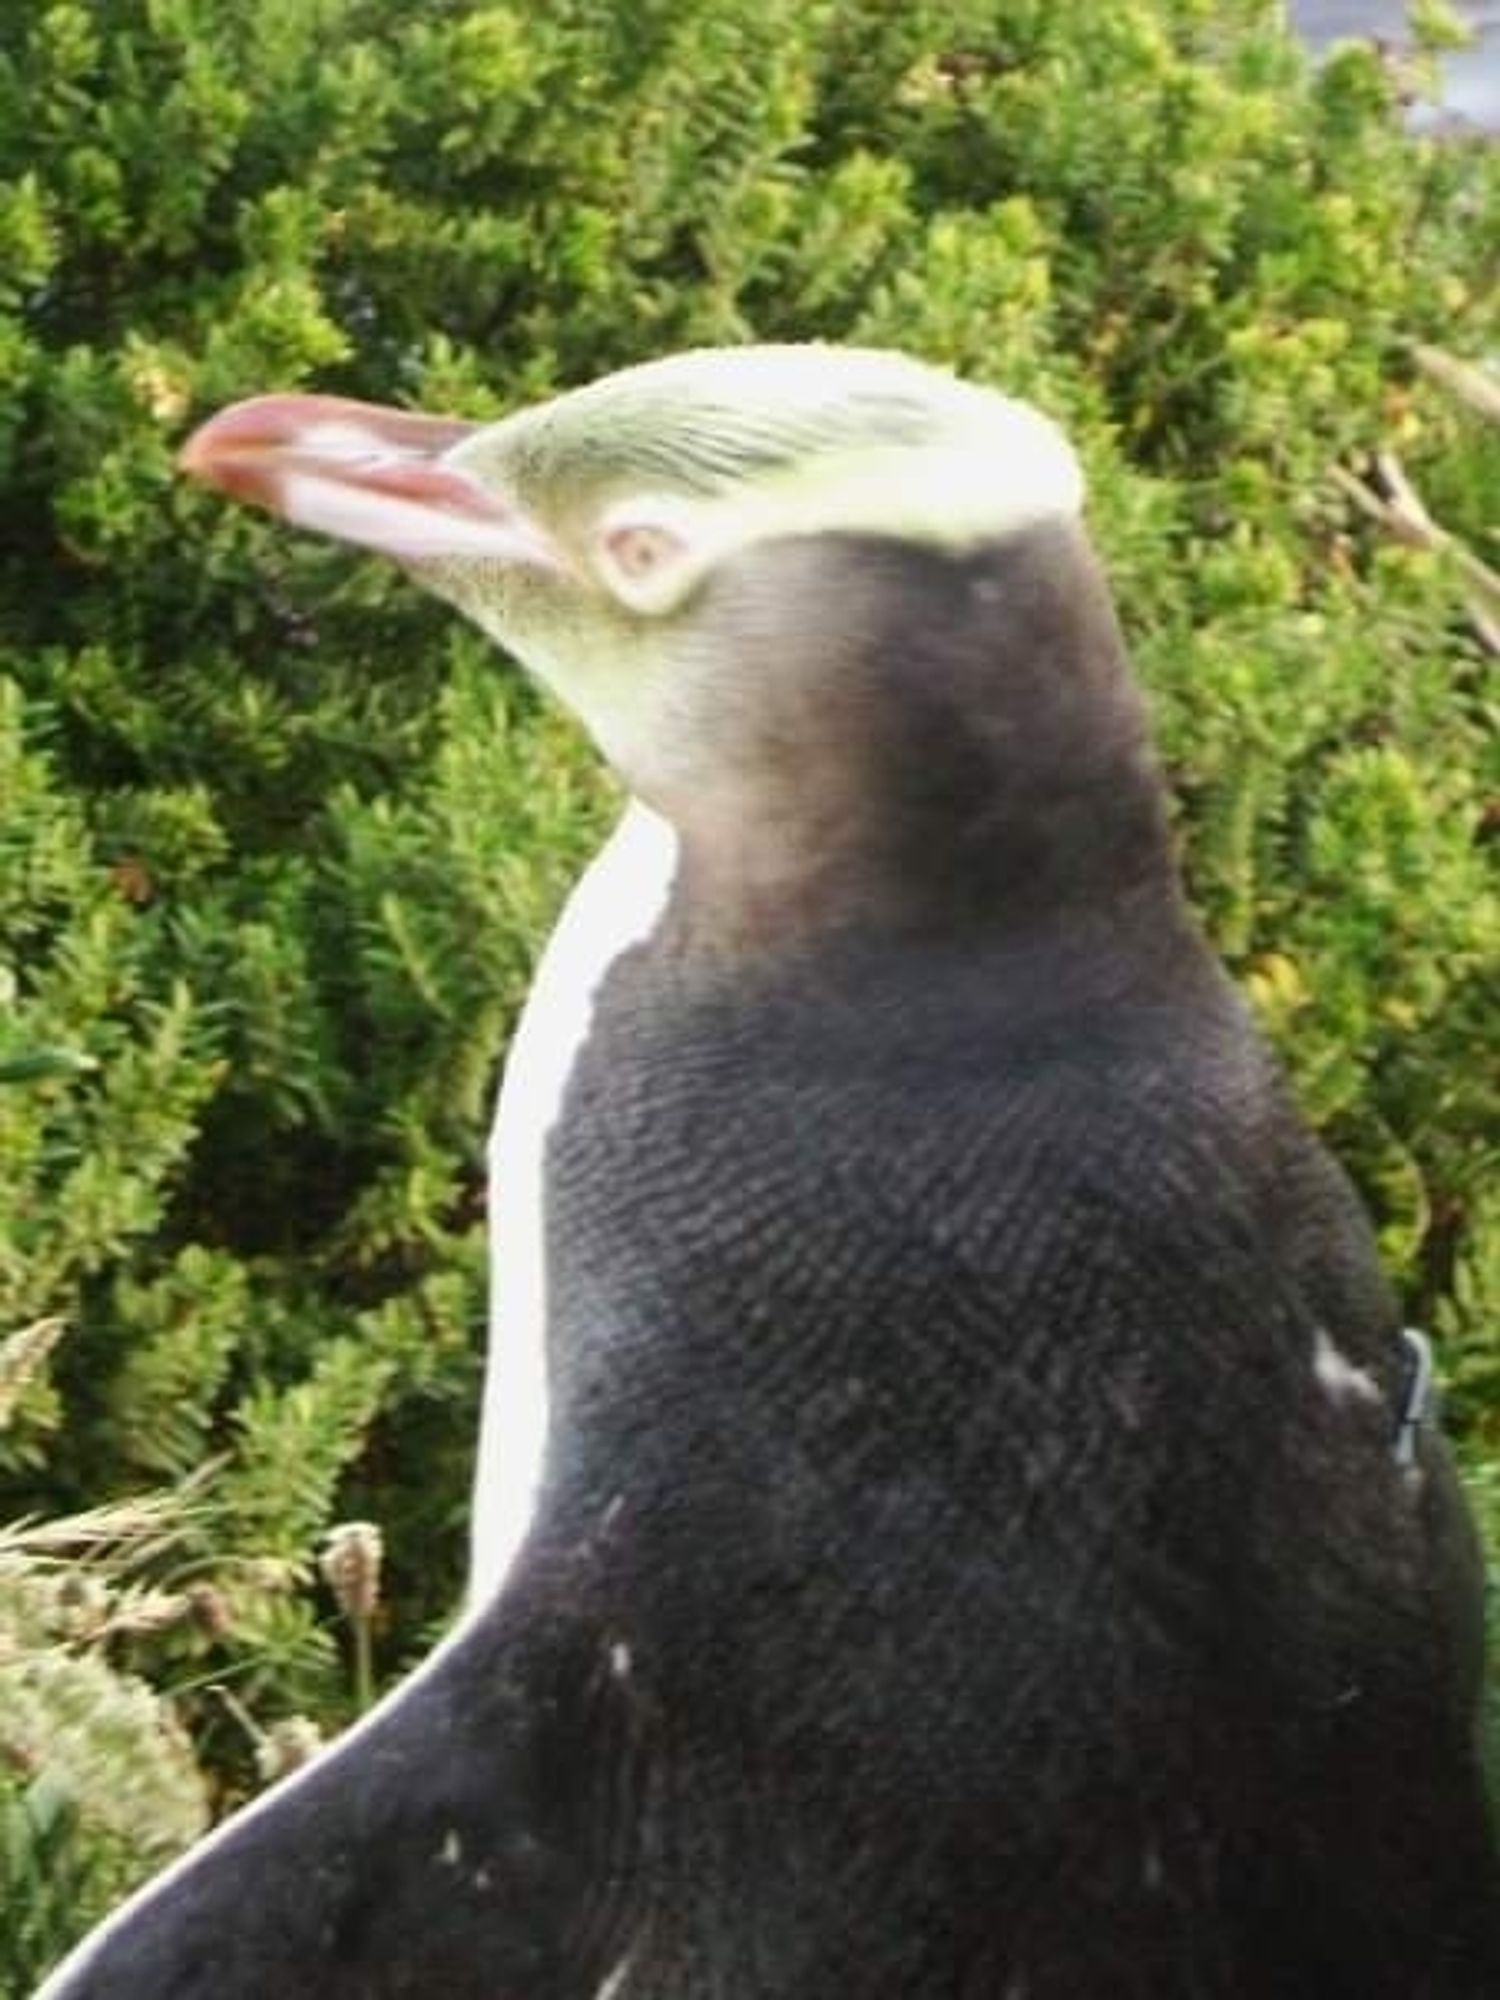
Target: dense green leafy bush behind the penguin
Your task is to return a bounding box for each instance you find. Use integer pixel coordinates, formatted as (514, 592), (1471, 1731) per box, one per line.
(0, 0), (1500, 1994)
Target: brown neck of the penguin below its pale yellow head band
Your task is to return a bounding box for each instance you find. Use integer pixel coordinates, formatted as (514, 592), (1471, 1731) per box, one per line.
(662, 524), (1180, 938)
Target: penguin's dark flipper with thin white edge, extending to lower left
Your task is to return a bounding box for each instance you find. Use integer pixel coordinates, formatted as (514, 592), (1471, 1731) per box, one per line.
(36, 1592), (632, 2000)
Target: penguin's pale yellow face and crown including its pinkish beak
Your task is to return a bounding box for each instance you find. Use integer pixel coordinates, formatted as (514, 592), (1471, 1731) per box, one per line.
(182, 346), (1082, 814)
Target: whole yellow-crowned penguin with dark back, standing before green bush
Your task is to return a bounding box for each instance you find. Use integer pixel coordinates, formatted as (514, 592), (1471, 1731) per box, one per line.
(42, 346), (1500, 2000)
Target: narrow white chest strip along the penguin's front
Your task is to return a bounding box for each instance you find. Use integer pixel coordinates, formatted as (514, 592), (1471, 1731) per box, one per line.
(470, 802), (678, 1604)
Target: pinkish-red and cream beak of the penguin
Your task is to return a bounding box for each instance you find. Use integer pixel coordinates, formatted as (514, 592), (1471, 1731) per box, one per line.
(178, 396), (566, 570)
